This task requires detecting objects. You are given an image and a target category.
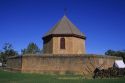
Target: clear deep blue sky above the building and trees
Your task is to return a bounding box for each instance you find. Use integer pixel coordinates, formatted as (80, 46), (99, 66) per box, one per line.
(0, 0), (125, 54)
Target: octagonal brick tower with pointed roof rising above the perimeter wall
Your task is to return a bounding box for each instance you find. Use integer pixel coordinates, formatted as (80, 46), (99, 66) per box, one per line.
(42, 15), (86, 54)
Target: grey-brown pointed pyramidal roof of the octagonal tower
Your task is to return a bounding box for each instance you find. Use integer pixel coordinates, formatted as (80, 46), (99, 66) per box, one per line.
(43, 15), (85, 38)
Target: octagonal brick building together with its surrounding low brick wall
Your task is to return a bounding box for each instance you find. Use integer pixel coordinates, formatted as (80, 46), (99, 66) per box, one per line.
(7, 15), (120, 75)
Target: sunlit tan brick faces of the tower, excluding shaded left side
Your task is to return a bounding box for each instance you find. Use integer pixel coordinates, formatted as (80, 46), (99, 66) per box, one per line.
(53, 37), (85, 54)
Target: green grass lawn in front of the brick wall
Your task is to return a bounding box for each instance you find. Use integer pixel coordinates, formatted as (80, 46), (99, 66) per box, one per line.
(0, 70), (125, 83)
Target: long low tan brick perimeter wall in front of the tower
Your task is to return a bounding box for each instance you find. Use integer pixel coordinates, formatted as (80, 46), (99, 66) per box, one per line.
(8, 55), (120, 75)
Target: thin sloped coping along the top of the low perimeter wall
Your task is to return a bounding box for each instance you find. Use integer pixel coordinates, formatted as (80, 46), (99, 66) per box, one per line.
(8, 54), (122, 59)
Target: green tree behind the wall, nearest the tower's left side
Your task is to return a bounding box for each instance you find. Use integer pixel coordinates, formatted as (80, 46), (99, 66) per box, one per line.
(21, 42), (40, 54)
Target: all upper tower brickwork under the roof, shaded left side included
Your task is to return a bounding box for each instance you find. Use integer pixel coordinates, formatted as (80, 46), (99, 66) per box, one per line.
(43, 37), (85, 54)
